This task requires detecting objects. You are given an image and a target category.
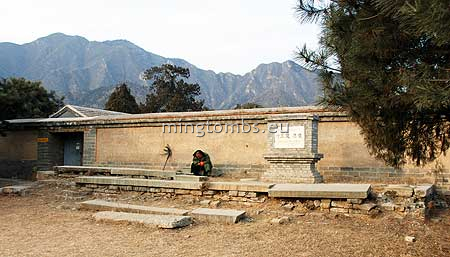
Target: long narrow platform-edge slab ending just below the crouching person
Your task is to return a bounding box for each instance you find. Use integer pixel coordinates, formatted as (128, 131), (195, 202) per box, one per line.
(75, 176), (204, 190)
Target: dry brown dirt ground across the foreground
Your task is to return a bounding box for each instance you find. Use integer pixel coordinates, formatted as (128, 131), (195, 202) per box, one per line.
(0, 181), (450, 256)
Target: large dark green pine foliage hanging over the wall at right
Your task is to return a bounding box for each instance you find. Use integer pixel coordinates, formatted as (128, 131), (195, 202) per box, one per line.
(297, 0), (450, 166)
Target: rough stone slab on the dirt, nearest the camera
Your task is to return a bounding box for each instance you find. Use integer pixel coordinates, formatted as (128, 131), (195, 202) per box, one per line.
(93, 211), (192, 228)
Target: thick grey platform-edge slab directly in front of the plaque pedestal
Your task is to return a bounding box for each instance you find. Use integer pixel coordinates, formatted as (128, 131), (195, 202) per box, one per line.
(269, 184), (370, 199)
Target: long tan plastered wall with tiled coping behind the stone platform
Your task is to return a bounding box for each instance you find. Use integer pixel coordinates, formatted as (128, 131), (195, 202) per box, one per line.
(0, 107), (450, 192)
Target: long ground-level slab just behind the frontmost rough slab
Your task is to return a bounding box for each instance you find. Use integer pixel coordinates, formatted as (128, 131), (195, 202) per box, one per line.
(81, 200), (189, 216)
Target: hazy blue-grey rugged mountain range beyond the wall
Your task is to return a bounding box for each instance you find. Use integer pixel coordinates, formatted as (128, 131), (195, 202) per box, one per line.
(0, 33), (321, 109)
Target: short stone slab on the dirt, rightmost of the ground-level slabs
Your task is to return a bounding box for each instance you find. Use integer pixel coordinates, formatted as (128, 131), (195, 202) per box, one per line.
(191, 208), (245, 224)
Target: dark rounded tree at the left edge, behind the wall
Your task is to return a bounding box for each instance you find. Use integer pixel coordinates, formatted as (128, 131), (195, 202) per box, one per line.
(0, 78), (64, 121)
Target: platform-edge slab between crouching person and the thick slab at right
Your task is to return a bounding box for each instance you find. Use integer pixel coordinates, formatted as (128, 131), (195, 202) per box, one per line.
(207, 181), (274, 193)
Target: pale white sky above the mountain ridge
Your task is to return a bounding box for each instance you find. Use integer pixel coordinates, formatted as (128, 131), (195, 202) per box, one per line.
(0, 0), (320, 74)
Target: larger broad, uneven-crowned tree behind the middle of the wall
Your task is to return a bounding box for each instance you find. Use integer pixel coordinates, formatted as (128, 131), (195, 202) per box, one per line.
(142, 64), (204, 112)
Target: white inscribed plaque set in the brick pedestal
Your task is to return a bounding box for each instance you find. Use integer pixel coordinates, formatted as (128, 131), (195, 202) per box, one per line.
(273, 124), (305, 148)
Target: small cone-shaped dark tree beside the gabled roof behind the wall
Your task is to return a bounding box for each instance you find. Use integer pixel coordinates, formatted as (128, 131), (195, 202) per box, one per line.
(105, 83), (140, 113)
